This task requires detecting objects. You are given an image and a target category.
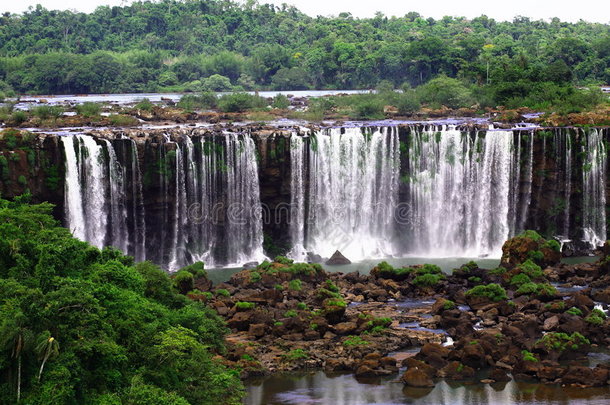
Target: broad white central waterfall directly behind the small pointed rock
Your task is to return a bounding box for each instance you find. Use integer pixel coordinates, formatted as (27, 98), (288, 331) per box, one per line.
(291, 128), (400, 260)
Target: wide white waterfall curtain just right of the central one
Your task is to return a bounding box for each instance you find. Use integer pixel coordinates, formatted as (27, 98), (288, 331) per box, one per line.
(408, 127), (519, 256)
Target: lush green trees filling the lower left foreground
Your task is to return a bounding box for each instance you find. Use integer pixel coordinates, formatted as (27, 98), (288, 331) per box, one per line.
(0, 197), (243, 405)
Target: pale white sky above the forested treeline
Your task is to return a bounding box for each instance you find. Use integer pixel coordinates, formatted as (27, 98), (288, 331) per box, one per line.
(0, 0), (610, 24)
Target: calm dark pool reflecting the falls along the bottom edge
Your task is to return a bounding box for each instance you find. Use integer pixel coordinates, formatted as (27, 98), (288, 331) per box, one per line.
(245, 372), (610, 405)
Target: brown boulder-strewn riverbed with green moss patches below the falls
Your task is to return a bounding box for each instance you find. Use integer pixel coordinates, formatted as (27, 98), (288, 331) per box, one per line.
(176, 231), (610, 387)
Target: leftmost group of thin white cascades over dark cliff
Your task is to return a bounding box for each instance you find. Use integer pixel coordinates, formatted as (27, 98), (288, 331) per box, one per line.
(61, 134), (265, 271)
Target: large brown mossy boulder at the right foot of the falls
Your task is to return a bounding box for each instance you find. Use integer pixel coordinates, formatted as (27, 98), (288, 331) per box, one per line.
(500, 231), (561, 269)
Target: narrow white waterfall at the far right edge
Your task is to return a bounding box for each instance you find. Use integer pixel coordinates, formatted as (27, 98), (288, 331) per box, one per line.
(582, 129), (607, 248)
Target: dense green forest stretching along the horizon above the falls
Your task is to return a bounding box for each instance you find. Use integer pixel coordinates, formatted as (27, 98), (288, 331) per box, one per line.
(0, 0), (610, 104)
